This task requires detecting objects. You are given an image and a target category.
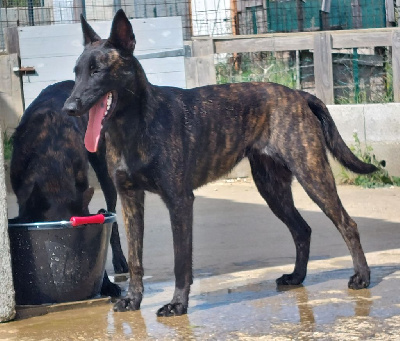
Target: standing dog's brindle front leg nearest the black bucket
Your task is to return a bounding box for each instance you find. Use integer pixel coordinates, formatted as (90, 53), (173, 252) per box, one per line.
(114, 190), (144, 311)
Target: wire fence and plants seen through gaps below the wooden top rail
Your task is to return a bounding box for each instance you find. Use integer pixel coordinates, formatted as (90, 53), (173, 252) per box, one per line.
(215, 47), (393, 104)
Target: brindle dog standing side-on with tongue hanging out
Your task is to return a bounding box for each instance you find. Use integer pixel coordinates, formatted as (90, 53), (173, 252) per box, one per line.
(64, 10), (376, 316)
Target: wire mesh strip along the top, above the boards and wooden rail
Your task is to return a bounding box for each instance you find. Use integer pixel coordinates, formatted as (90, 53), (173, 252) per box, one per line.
(0, 0), (398, 46)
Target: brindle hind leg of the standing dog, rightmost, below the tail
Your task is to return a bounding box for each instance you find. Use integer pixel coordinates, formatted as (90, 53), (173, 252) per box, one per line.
(291, 148), (370, 289)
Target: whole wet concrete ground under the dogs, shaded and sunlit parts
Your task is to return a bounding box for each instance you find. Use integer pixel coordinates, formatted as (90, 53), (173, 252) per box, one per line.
(0, 179), (400, 340)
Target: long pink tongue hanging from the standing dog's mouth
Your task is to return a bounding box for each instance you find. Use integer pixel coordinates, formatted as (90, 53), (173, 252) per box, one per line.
(85, 94), (108, 153)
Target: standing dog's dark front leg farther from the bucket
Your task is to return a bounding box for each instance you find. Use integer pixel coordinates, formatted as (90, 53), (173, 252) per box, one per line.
(157, 193), (194, 316)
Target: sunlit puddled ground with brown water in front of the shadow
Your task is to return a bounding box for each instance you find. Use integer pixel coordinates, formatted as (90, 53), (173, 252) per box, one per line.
(0, 249), (400, 341)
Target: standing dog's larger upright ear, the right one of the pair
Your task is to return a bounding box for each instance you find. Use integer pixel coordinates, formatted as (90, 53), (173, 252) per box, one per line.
(108, 9), (136, 53)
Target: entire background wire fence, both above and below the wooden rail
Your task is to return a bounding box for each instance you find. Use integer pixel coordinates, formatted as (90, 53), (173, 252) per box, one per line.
(0, 0), (398, 103)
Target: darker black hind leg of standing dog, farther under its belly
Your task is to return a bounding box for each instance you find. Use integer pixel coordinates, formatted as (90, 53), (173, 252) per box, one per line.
(249, 153), (311, 285)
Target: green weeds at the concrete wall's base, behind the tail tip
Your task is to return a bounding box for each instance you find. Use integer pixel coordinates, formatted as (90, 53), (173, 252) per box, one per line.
(340, 133), (400, 188)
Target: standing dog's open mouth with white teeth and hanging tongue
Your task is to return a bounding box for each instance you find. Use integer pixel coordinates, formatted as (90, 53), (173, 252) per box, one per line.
(85, 91), (118, 153)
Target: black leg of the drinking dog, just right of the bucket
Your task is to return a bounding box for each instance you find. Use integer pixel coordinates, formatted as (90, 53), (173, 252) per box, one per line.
(88, 149), (129, 274)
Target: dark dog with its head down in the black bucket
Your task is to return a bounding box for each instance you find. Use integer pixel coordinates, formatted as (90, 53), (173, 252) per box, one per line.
(10, 81), (128, 296)
